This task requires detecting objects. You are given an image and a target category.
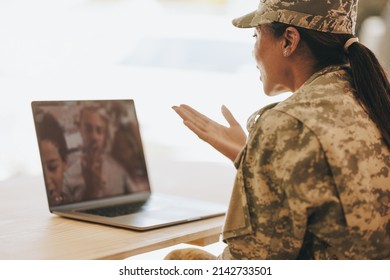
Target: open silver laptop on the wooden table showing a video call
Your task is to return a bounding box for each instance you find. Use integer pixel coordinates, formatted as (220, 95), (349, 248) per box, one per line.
(31, 100), (226, 231)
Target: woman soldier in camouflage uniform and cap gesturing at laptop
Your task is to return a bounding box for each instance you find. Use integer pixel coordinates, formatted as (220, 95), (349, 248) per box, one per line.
(166, 0), (390, 259)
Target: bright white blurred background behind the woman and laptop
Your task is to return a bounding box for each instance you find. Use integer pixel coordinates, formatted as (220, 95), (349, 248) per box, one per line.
(0, 0), (384, 180)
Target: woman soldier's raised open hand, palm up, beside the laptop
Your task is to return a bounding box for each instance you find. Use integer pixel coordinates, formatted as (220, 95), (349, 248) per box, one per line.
(172, 105), (246, 161)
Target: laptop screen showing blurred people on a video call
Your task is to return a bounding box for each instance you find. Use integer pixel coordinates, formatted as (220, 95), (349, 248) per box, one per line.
(32, 100), (150, 206)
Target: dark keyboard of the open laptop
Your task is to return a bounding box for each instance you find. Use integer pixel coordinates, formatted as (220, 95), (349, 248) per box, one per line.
(80, 201), (145, 218)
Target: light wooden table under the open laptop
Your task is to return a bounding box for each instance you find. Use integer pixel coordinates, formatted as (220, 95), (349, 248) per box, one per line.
(0, 161), (232, 260)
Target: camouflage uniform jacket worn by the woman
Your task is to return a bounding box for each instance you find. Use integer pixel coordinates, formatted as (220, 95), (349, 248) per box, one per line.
(219, 66), (390, 259)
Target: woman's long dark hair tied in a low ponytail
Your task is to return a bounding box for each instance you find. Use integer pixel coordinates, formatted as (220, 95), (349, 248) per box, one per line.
(270, 22), (390, 148)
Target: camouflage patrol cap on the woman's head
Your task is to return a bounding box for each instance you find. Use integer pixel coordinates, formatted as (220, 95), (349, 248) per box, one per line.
(233, 0), (358, 34)
